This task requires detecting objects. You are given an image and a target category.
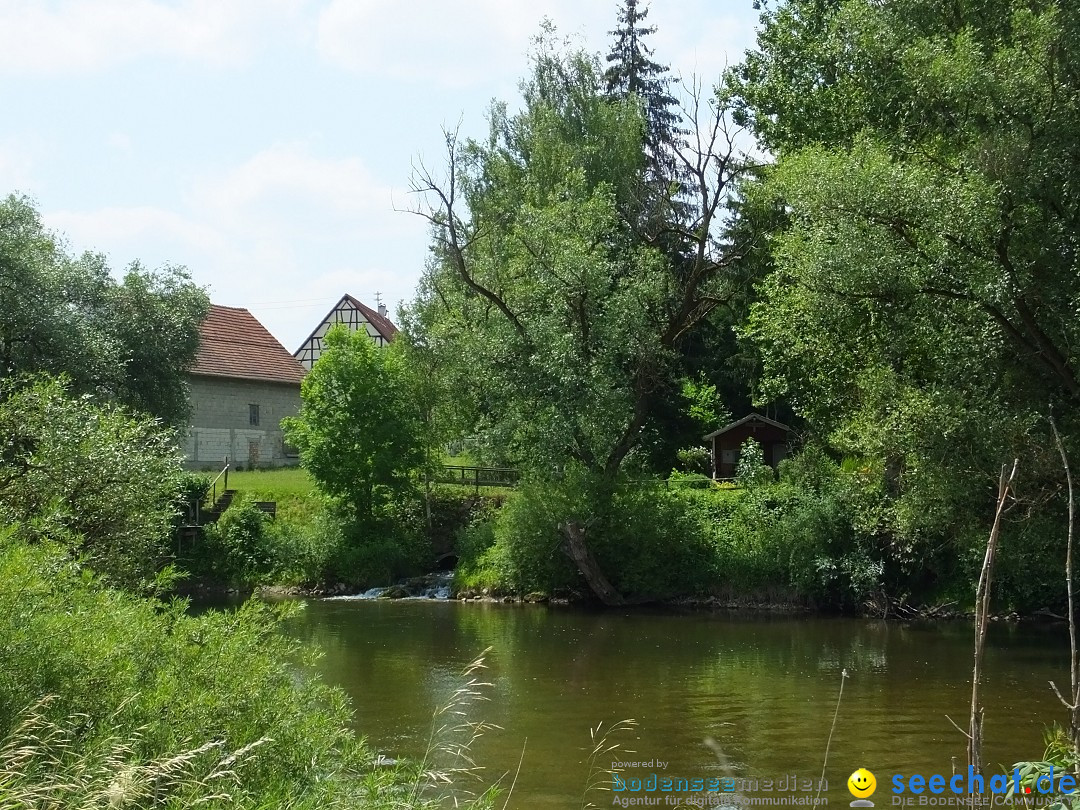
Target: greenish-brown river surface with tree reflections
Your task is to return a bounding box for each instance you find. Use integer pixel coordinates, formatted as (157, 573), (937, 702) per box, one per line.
(278, 600), (1068, 808)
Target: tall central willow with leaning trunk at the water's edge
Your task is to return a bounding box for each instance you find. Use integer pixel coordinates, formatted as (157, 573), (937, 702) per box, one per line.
(411, 30), (738, 603)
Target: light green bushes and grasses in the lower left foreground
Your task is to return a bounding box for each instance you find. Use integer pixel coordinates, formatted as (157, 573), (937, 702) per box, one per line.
(0, 527), (490, 810)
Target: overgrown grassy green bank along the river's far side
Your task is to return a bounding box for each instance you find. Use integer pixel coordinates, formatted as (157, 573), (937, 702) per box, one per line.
(192, 455), (1058, 612)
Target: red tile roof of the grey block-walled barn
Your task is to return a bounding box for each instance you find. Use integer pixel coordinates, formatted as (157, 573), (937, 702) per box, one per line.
(191, 303), (307, 384)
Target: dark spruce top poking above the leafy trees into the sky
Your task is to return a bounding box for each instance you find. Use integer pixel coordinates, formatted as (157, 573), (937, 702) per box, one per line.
(604, 0), (680, 183)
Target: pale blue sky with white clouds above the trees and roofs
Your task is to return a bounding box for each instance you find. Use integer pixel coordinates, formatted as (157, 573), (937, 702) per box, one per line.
(0, 0), (758, 351)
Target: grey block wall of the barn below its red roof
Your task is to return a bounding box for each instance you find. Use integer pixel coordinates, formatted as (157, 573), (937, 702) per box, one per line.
(184, 376), (300, 470)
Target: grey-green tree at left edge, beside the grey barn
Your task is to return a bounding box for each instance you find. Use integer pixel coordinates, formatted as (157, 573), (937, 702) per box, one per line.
(0, 197), (210, 426)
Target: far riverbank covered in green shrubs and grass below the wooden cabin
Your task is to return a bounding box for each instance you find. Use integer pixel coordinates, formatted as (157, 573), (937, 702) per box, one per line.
(192, 468), (1064, 620)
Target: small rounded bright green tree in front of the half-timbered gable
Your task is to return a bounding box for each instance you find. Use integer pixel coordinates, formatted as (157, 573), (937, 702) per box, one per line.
(282, 325), (423, 529)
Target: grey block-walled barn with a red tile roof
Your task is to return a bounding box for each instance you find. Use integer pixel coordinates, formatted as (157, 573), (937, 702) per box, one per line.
(185, 305), (306, 469)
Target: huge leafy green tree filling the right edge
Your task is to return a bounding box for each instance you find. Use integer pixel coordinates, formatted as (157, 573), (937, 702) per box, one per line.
(738, 0), (1080, 596)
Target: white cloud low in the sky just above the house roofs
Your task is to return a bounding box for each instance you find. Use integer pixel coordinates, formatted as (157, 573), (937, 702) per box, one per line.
(45, 144), (427, 350)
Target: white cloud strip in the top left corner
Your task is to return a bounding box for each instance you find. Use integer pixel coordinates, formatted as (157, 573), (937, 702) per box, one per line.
(0, 0), (304, 73)
